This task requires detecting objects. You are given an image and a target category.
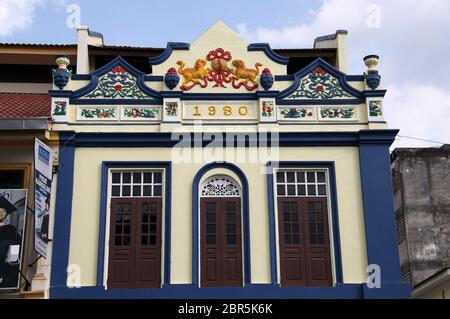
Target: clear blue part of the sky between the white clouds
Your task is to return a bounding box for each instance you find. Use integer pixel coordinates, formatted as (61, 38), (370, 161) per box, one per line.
(0, 0), (321, 47)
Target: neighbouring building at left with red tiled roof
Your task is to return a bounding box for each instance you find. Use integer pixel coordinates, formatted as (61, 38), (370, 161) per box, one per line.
(0, 43), (72, 298)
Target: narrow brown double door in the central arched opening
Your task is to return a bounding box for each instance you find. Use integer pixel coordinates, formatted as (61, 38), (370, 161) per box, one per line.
(200, 197), (243, 287)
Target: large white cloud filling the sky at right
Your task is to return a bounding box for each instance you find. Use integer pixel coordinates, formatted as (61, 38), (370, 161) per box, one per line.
(237, 0), (450, 146)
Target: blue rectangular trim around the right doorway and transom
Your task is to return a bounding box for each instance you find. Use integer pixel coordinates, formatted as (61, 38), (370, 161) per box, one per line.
(267, 161), (343, 285)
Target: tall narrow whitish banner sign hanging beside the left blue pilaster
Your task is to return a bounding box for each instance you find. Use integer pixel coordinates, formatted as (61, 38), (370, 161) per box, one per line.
(34, 139), (53, 258)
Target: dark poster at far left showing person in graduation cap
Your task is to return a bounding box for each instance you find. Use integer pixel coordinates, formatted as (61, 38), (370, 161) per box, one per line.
(0, 189), (27, 289)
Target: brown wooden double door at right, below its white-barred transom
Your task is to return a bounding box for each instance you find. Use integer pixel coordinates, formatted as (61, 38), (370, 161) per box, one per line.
(278, 197), (332, 287)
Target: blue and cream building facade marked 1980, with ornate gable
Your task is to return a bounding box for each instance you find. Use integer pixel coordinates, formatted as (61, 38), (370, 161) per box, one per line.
(50, 22), (410, 298)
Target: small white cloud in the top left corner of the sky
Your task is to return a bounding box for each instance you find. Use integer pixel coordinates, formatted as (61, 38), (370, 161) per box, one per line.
(0, 0), (46, 36)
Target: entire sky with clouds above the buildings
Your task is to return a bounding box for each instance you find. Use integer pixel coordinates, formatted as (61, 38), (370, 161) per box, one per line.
(0, 0), (450, 147)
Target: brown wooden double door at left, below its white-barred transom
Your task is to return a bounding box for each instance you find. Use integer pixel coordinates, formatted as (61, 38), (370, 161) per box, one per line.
(108, 198), (162, 288)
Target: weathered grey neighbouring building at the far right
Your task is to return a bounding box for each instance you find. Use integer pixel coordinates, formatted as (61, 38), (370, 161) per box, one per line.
(391, 145), (450, 299)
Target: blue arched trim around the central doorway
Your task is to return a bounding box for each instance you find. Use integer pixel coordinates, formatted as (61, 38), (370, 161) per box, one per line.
(192, 162), (252, 287)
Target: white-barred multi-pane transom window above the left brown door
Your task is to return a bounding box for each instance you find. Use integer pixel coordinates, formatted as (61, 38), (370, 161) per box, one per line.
(111, 171), (163, 197)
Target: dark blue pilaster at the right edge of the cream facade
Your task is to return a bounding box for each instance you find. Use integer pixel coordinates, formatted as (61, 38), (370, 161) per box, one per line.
(359, 130), (406, 298)
